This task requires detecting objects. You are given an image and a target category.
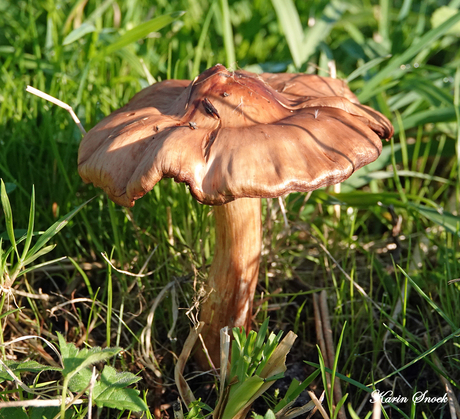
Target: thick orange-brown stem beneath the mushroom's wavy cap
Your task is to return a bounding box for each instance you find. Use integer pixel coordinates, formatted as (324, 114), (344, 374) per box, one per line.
(197, 198), (262, 367)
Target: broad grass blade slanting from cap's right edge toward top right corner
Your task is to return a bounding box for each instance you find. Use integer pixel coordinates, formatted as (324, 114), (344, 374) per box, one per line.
(358, 12), (460, 102)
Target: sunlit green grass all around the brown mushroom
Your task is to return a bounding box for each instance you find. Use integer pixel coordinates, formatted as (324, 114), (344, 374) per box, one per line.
(0, 0), (460, 418)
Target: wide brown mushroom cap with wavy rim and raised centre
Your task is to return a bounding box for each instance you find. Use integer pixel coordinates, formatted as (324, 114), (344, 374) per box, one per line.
(78, 64), (393, 207)
